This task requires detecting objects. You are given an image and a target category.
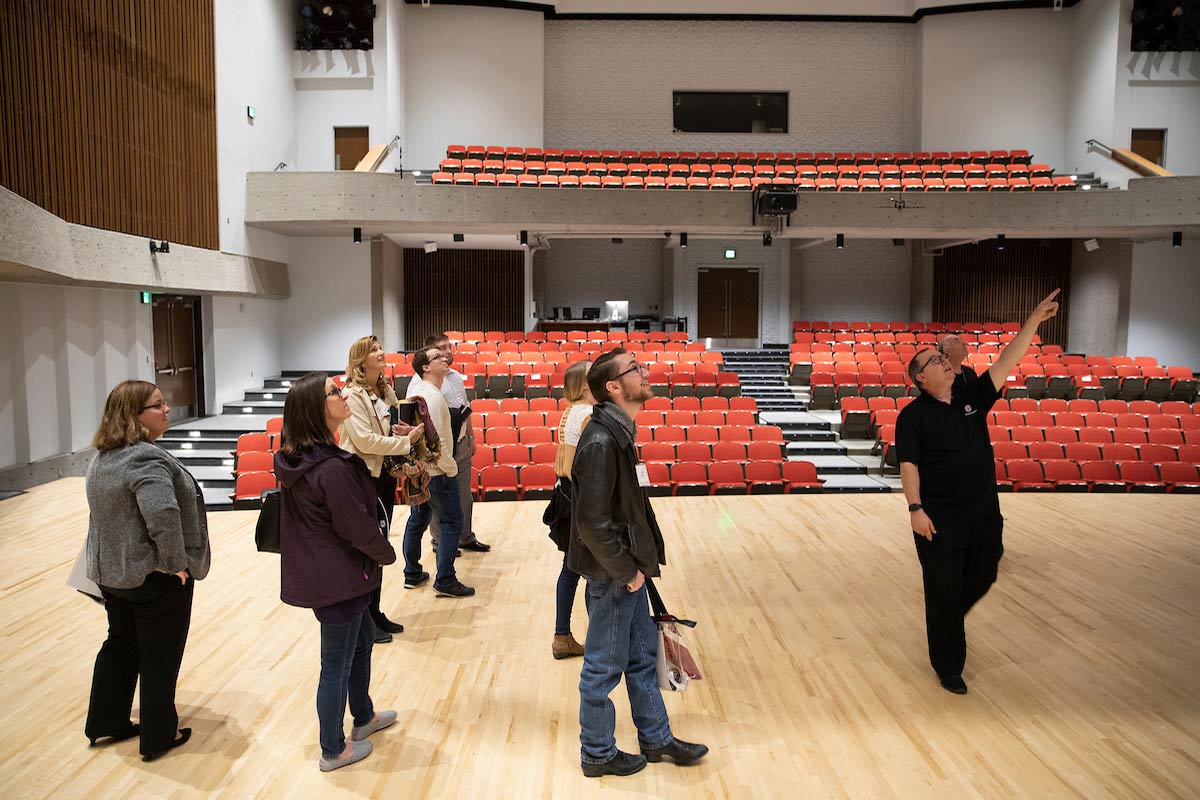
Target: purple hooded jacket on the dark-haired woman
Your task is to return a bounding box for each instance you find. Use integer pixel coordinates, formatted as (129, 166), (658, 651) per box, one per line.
(275, 446), (396, 608)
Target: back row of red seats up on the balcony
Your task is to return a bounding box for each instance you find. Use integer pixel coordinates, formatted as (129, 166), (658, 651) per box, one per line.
(446, 144), (1031, 164)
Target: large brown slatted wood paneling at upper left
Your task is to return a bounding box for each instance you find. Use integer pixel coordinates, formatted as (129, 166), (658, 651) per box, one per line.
(0, 0), (220, 249)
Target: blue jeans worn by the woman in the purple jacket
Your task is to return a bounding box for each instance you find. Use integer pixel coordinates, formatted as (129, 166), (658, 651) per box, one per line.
(317, 610), (374, 758)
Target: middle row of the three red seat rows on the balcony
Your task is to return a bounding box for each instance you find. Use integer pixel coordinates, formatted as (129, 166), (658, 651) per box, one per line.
(434, 158), (1054, 181)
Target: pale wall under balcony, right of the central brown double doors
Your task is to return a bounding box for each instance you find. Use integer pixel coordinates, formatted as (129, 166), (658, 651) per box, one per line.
(785, 239), (912, 323)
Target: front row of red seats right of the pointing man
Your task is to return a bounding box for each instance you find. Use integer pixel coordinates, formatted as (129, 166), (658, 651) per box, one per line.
(996, 459), (1200, 494)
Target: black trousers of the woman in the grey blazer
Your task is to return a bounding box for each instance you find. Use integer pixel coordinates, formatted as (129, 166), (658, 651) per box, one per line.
(84, 572), (196, 756)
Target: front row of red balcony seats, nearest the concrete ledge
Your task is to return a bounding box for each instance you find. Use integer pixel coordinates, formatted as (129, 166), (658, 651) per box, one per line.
(431, 172), (1076, 192)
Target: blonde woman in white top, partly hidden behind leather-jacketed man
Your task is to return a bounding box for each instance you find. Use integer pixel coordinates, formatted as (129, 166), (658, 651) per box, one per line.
(547, 361), (595, 658)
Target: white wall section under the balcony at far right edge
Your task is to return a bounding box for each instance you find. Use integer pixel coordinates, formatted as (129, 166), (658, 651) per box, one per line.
(1128, 239), (1200, 371)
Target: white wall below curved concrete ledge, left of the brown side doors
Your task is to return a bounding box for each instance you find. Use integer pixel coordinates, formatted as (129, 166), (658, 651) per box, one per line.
(0, 283), (154, 468)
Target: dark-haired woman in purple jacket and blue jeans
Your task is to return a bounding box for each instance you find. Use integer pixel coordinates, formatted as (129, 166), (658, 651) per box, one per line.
(275, 372), (396, 772)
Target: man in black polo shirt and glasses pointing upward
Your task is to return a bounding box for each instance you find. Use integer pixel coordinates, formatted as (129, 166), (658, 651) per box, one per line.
(896, 289), (1060, 694)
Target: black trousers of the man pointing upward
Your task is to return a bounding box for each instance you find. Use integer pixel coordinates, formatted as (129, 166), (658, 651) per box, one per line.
(913, 512), (1004, 678)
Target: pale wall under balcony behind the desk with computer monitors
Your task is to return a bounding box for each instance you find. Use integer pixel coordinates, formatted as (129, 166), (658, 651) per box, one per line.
(539, 239), (664, 315)
